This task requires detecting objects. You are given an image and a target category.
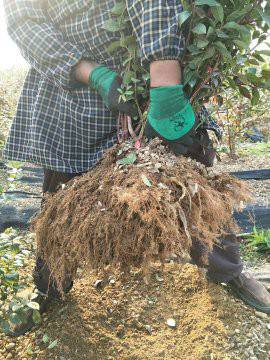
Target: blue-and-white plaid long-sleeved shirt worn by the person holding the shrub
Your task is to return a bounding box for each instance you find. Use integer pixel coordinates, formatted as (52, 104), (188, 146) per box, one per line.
(4, 0), (188, 173)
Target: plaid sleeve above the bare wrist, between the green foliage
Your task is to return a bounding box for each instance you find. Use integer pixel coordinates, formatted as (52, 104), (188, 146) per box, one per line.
(126, 0), (183, 64)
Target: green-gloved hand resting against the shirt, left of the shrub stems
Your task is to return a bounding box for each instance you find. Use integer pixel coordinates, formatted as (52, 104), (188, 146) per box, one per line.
(89, 66), (138, 117)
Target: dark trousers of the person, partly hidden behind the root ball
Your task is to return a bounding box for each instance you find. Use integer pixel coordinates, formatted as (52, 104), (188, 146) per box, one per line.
(33, 169), (243, 298)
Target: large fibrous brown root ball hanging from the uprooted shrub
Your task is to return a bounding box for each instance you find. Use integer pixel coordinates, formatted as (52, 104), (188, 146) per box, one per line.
(32, 141), (248, 294)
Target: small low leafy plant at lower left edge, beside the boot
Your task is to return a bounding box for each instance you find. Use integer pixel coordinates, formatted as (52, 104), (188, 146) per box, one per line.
(0, 229), (41, 334)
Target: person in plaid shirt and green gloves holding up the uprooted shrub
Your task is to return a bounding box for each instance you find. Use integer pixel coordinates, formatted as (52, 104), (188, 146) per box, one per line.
(4, 0), (270, 336)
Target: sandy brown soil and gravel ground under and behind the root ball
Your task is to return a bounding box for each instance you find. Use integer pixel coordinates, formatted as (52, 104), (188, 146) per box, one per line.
(0, 144), (270, 360)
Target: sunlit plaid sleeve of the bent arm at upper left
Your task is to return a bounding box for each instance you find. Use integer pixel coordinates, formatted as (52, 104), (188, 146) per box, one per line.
(4, 0), (83, 89)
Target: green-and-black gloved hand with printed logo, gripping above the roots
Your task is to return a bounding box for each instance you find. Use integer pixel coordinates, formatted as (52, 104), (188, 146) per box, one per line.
(145, 85), (197, 155)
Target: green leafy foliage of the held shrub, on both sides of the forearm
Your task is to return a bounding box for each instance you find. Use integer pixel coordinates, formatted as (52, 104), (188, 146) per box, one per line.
(104, 0), (270, 113)
